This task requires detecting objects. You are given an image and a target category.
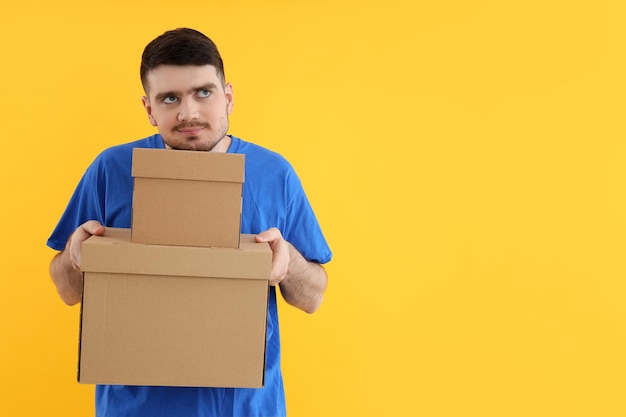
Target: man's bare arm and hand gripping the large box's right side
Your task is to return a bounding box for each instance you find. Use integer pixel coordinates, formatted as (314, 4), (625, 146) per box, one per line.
(256, 228), (328, 314)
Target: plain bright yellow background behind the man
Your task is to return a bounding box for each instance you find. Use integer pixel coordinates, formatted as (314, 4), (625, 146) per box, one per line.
(0, 0), (626, 417)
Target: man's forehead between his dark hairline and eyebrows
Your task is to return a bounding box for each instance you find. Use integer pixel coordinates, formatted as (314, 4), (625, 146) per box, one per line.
(146, 65), (222, 96)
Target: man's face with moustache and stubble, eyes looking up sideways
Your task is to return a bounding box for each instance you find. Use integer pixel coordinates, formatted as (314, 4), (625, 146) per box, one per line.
(142, 65), (233, 152)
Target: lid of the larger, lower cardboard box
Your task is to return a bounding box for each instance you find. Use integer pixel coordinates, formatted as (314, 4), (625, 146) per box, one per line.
(81, 227), (272, 280)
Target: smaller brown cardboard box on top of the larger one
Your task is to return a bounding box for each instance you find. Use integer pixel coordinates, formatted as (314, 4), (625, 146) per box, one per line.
(132, 148), (245, 248)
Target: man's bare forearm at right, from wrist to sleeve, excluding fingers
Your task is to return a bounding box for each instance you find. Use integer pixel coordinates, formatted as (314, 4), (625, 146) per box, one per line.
(279, 244), (328, 314)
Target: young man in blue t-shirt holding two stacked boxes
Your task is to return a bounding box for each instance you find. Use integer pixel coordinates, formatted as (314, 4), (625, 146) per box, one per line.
(48, 29), (332, 417)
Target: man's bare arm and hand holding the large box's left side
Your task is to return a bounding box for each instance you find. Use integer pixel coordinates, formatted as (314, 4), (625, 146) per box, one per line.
(50, 220), (104, 305)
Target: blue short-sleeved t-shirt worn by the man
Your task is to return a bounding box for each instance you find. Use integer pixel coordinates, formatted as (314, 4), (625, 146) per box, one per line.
(48, 134), (332, 417)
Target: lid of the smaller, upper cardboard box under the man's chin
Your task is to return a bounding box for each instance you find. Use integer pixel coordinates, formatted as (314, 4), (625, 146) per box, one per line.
(132, 148), (245, 183)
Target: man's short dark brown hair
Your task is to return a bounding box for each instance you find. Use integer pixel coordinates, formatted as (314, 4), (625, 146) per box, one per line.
(139, 28), (225, 91)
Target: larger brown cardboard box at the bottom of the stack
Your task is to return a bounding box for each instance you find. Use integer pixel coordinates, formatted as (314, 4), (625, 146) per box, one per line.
(78, 228), (272, 388)
